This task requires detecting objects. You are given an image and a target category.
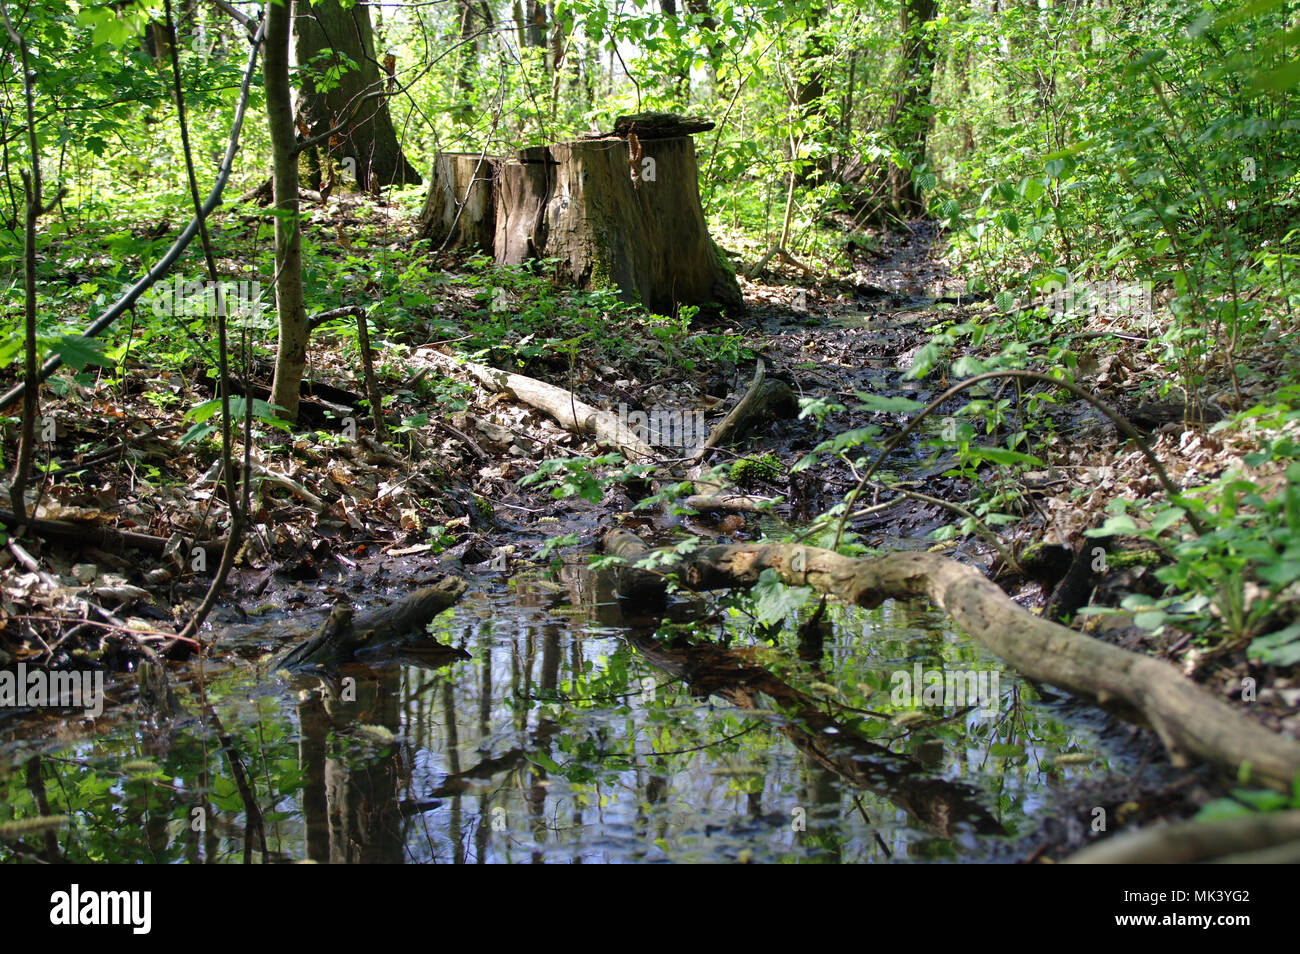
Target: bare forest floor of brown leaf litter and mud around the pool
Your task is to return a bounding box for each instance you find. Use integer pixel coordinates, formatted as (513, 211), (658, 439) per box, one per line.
(0, 196), (1300, 845)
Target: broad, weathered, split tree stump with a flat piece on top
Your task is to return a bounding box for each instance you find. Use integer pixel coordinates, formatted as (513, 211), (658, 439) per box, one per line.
(421, 114), (744, 315)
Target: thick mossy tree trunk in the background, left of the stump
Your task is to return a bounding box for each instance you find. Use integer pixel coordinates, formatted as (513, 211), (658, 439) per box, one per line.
(294, 0), (421, 187)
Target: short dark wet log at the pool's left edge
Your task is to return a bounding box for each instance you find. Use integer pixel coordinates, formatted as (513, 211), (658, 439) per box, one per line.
(272, 576), (465, 669)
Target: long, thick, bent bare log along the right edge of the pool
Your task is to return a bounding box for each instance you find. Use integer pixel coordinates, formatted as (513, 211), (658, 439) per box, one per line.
(605, 530), (1300, 790)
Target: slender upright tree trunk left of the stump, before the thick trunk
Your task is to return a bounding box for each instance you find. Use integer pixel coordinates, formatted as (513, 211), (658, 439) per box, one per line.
(261, 3), (311, 421)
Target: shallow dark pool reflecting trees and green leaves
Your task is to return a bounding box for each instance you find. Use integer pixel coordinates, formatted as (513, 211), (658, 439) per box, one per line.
(0, 565), (1123, 863)
